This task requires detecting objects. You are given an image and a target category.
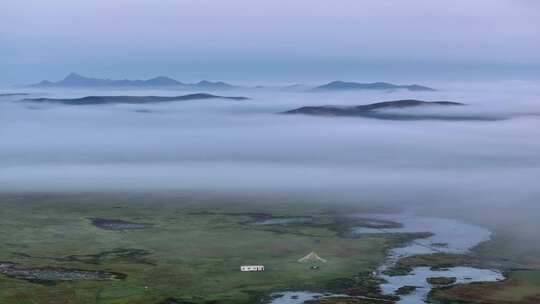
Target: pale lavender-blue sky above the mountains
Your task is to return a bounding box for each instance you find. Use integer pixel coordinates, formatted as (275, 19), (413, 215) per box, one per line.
(0, 0), (540, 85)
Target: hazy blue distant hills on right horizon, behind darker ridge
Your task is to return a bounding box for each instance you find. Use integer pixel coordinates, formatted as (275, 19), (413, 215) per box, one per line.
(313, 81), (435, 91)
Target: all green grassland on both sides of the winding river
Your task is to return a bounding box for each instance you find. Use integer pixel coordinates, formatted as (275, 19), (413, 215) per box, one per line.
(0, 193), (540, 304)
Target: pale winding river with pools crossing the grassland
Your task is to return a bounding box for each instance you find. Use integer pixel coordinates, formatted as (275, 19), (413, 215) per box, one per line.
(270, 214), (504, 304)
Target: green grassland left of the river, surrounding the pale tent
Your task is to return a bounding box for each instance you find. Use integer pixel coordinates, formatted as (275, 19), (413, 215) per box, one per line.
(0, 194), (405, 304)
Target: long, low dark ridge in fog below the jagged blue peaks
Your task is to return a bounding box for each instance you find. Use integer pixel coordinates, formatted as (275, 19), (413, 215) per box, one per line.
(22, 94), (248, 105)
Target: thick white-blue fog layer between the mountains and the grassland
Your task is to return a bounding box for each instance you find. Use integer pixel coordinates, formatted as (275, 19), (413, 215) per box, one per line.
(0, 82), (540, 228)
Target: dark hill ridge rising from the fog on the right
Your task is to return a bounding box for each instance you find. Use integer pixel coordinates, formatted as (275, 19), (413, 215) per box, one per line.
(282, 99), (501, 120)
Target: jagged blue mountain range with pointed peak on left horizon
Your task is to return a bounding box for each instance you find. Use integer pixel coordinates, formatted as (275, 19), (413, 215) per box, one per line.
(28, 73), (234, 90)
